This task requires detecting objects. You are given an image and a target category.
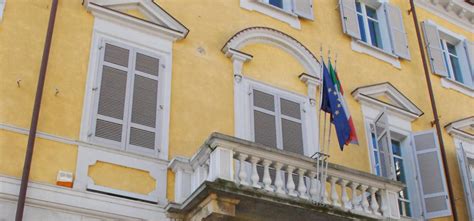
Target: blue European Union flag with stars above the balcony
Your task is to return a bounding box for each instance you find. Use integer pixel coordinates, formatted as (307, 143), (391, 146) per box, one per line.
(321, 62), (351, 150)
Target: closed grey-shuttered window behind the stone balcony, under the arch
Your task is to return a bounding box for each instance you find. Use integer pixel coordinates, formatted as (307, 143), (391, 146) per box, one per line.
(251, 88), (304, 154)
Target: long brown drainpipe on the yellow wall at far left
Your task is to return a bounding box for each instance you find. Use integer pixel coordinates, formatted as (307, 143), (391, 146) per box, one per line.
(15, 0), (58, 221)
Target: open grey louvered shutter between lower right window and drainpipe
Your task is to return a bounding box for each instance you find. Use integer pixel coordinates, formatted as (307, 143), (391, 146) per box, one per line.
(413, 130), (451, 219)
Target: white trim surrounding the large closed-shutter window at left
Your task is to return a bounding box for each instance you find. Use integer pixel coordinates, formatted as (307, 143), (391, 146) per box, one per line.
(80, 17), (172, 160)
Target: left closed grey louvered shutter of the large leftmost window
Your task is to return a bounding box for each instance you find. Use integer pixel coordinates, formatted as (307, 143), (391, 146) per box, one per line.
(94, 43), (130, 143)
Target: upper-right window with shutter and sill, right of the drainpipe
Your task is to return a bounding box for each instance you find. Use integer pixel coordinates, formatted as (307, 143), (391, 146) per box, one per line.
(422, 21), (474, 90)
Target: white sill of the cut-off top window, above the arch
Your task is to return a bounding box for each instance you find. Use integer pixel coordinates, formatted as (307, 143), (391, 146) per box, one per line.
(240, 0), (301, 29)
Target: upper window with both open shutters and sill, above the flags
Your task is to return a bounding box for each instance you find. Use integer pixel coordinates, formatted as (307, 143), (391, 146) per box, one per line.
(339, 0), (410, 64)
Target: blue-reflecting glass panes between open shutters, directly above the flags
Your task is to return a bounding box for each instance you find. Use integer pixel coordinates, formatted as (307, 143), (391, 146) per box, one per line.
(356, 2), (383, 49)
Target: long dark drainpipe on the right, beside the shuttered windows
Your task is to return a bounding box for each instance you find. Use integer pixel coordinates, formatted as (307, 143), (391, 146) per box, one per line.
(410, 0), (458, 221)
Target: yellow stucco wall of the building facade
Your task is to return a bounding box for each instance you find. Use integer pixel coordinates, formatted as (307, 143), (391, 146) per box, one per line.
(0, 0), (474, 220)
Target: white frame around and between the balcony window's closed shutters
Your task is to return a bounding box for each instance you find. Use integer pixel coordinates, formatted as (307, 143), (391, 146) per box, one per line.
(249, 80), (310, 155)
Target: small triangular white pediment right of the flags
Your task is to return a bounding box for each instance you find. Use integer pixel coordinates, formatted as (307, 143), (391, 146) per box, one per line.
(352, 82), (423, 121)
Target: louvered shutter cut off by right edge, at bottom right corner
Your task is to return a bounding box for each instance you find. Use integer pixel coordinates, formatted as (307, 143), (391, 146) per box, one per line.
(457, 142), (474, 220)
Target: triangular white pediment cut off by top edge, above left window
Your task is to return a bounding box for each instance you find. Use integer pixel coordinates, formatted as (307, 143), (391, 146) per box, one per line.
(84, 0), (189, 41)
